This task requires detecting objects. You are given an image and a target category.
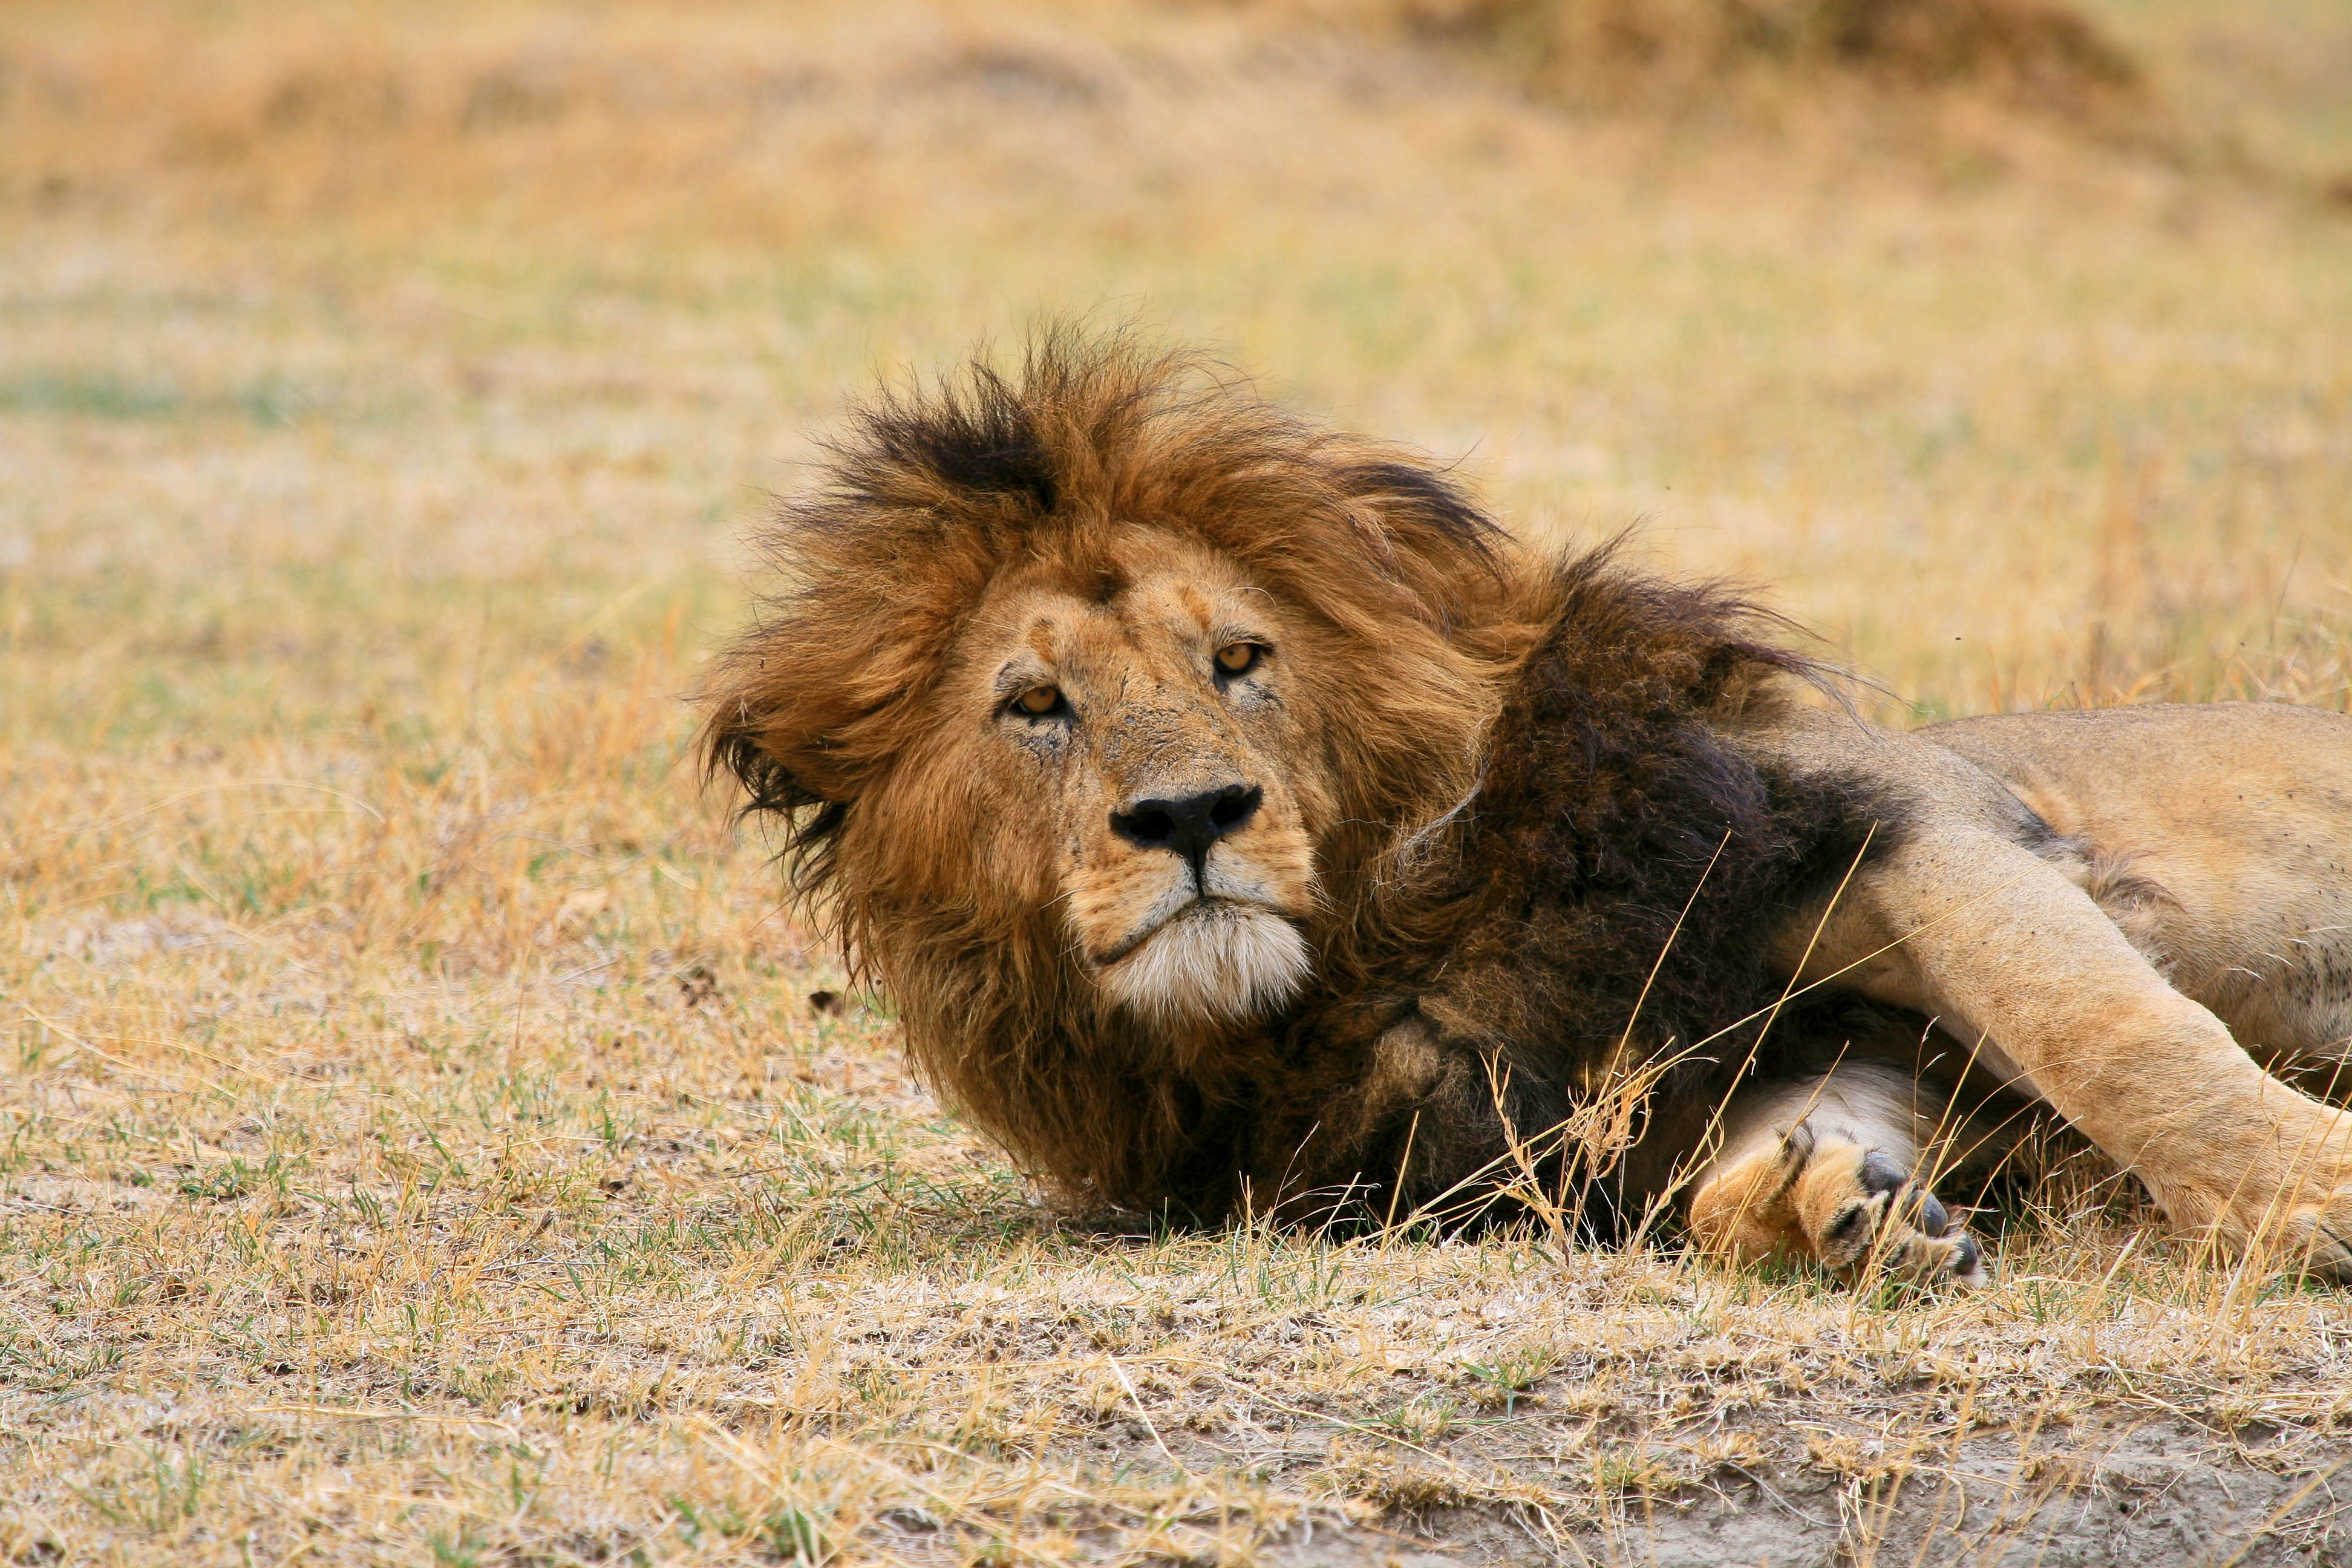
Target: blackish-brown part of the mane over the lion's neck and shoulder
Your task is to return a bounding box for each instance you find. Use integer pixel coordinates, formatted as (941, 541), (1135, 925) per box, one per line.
(1242, 557), (1907, 1234)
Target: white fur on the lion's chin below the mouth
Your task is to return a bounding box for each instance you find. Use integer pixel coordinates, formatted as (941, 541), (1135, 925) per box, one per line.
(1099, 903), (1315, 1025)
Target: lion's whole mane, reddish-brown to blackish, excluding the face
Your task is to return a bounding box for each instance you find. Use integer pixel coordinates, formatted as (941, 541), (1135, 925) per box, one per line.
(705, 332), (1901, 1218)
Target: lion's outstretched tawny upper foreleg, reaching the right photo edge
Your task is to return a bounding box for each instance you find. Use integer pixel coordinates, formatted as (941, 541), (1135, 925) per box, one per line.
(1804, 830), (2352, 1281)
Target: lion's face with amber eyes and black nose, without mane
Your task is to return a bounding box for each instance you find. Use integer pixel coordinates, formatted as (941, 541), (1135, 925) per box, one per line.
(938, 529), (1333, 1027)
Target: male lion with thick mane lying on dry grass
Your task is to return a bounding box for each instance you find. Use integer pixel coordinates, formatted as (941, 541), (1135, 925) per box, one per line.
(705, 334), (2352, 1284)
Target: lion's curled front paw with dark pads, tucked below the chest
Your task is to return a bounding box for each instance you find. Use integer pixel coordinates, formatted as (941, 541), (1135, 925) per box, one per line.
(1691, 1065), (1985, 1286)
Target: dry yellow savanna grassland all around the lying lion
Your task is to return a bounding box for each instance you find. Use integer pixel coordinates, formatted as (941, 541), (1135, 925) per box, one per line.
(0, 0), (2352, 1566)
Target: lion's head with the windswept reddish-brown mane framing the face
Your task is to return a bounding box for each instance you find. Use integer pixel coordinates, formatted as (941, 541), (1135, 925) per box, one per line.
(708, 332), (1534, 1178)
